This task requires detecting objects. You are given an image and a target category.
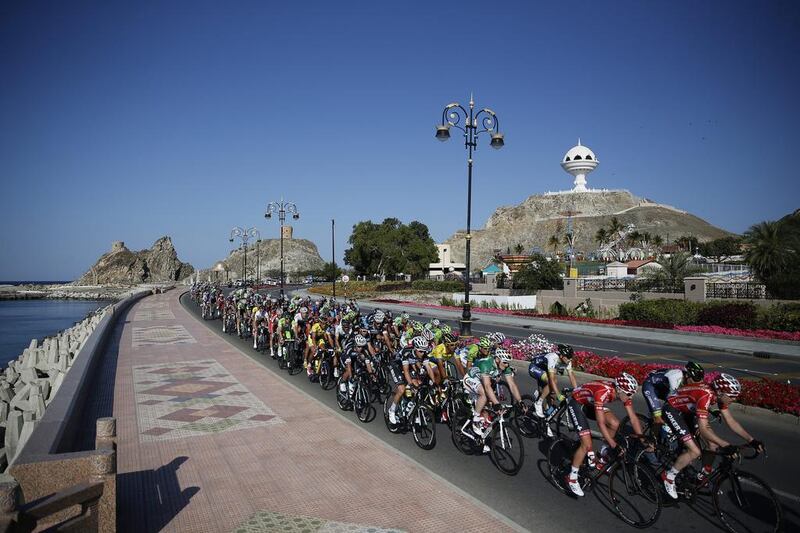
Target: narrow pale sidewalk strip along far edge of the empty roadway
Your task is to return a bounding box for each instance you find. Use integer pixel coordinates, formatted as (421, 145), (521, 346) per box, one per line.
(352, 295), (800, 358)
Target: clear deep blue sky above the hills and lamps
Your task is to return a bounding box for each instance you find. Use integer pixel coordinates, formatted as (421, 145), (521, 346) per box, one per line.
(0, 1), (800, 279)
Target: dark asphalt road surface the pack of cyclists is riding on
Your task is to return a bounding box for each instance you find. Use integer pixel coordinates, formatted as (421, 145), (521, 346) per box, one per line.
(181, 295), (800, 531)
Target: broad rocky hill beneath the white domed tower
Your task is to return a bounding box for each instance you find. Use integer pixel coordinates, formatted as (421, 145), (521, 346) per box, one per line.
(446, 191), (730, 269)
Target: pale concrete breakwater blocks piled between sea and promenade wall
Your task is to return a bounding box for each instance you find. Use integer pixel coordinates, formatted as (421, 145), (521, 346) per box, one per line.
(0, 305), (110, 471)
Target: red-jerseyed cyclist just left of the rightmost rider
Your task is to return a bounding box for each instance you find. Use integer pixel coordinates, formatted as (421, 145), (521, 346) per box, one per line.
(566, 372), (642, 496)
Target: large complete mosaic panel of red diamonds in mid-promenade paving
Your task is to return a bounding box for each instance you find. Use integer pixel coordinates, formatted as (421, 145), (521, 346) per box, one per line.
(133, 360), (283, 442)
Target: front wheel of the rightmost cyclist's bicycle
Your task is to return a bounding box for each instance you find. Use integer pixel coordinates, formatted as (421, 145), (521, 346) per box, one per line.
(713, 470), (783, 533)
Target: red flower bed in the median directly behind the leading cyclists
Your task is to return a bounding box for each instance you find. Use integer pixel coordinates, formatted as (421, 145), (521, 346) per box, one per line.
(572, 352), (800, 416)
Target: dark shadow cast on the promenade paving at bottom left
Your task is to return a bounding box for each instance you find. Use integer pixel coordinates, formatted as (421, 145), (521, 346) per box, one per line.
(117, 456), (200, 533)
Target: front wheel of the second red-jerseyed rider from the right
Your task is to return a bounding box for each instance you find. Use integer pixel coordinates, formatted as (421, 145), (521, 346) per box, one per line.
(606, 462), (661, 529)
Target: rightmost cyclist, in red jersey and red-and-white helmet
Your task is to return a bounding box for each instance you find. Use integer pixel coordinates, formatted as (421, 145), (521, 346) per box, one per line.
(661, 374), (764, 499)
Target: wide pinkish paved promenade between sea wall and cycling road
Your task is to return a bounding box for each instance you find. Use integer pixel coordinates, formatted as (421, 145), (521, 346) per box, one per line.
(111, 290), (512, 532)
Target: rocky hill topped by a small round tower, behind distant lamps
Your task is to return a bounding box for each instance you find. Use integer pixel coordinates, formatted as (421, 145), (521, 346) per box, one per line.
(200, 239), (325, 279)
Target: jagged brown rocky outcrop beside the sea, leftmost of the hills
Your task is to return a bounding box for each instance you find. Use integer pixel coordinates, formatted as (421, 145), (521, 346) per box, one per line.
(74, 237), (194, 285)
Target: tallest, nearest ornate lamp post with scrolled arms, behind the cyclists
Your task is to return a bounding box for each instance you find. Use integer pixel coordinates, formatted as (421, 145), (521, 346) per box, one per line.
(436, 95), (504, 336)
